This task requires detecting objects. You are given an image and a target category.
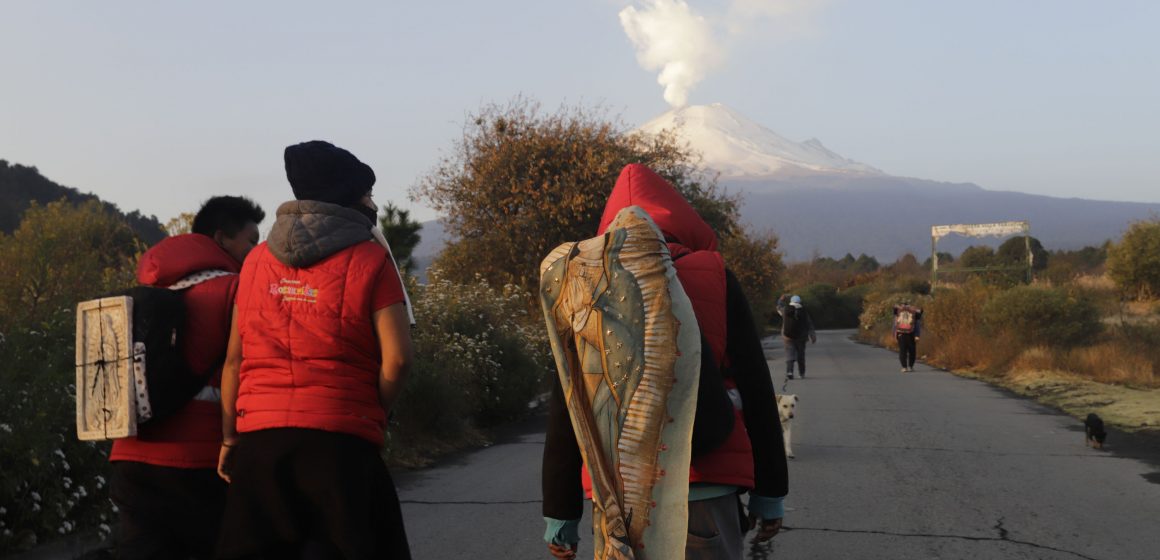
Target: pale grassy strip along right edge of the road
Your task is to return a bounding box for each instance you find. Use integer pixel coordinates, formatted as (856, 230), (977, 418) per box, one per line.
(951, 371), (1160, 434)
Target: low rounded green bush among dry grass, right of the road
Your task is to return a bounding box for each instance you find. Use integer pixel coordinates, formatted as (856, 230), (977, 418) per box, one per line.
(983, 286), (1102, 348)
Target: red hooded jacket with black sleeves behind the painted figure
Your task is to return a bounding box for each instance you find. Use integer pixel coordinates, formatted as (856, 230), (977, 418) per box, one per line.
(543, 165), (788, 519)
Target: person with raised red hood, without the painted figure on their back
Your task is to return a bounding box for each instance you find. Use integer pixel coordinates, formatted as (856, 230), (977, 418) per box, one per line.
(543, 163), (789, 559)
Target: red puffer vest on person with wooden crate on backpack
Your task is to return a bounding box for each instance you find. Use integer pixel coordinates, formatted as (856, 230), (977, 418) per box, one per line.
(109, 233), (240, 468)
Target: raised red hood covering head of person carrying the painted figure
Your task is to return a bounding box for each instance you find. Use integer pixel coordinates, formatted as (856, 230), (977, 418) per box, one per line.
(596, 163), (717, 250)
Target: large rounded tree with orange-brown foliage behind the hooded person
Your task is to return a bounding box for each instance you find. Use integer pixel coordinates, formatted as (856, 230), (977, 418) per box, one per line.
(412, 99), (738, 292)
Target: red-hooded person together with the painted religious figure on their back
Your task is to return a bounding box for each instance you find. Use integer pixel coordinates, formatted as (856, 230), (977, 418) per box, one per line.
(541, 165), (786, 560)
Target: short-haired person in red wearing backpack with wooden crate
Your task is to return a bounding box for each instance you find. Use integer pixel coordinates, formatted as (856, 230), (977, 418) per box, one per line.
(109, 196), (266, 559)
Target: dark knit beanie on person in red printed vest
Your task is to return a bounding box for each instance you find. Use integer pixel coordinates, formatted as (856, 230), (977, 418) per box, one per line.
(283, 140), (375, 206)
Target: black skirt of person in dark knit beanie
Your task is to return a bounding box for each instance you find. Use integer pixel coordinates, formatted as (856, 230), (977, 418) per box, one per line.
(218, 428), (411, 560)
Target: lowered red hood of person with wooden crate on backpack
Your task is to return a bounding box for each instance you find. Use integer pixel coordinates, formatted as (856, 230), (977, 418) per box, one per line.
(137, 233), (241, 288)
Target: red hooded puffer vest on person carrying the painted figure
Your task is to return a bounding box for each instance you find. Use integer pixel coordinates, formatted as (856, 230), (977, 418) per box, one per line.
(582, 163), (754, 492)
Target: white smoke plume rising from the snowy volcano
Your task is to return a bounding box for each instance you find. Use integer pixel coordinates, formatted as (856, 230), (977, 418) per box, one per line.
(619, 0), (828, 107)
